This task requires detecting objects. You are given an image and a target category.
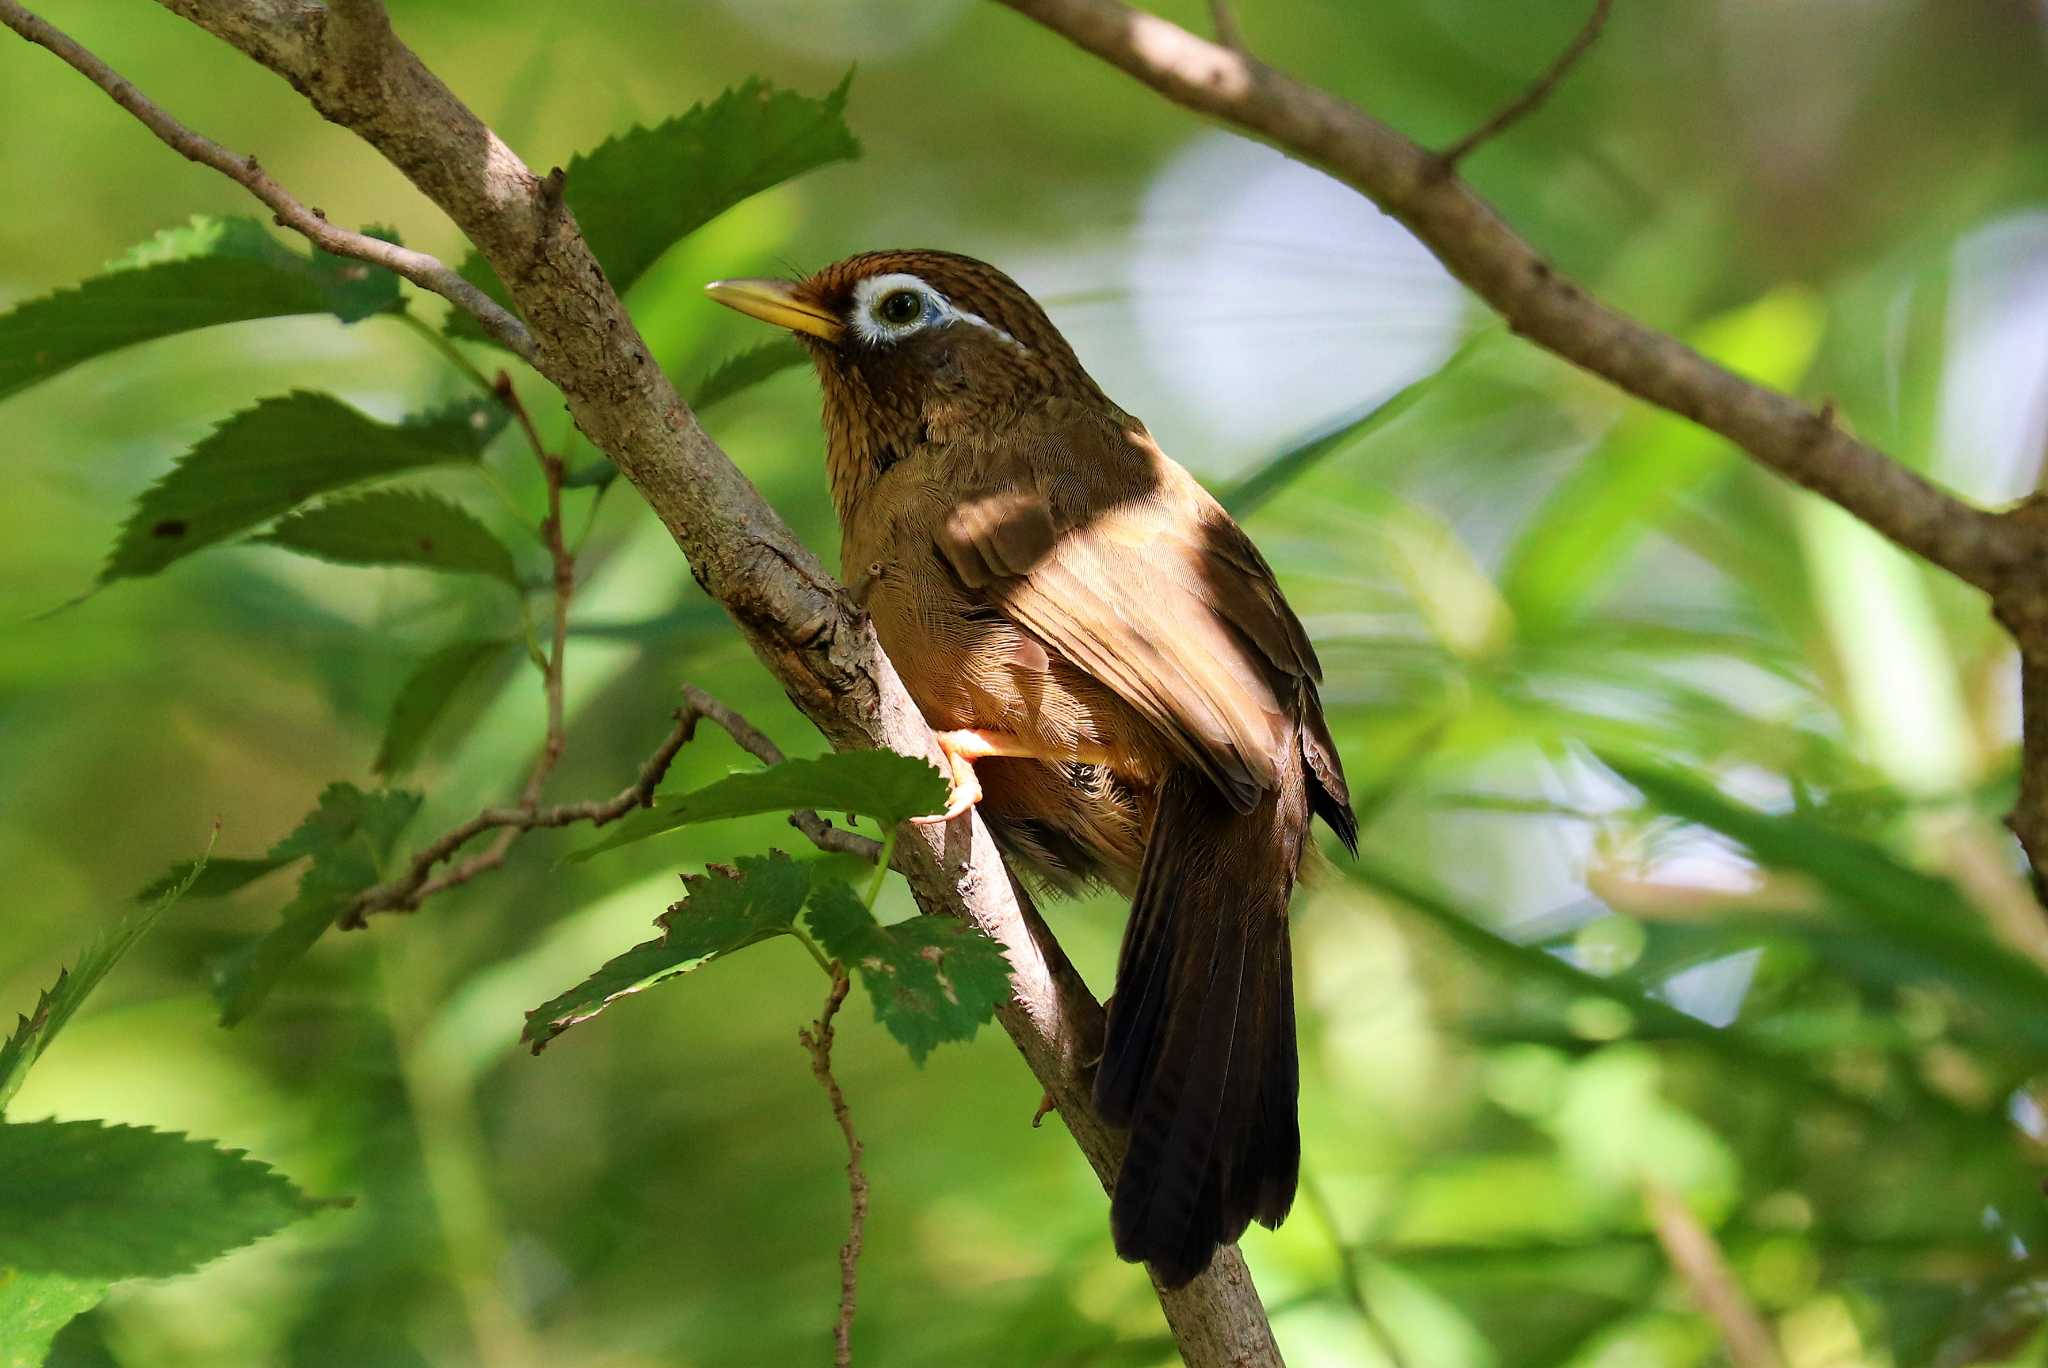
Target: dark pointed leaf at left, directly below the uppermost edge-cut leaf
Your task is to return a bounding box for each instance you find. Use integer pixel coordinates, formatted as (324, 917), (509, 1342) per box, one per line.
(100, 391), (504, 584)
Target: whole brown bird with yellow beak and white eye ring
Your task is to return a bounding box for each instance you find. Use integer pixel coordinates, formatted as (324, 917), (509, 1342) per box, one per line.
(707, 252), (1358, 1286)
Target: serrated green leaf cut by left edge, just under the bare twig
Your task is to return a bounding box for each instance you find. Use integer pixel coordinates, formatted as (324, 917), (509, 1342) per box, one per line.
(0, 217), (399, 399)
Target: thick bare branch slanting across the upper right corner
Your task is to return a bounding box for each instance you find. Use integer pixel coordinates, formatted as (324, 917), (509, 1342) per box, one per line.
(1001, 0), (2042, 592)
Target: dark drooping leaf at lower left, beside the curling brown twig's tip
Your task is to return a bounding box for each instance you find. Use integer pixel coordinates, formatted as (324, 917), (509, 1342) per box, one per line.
(213, 784), (420, 1026)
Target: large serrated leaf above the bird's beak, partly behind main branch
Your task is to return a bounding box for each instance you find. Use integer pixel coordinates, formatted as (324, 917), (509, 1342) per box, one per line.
(449, 74), (860, 340)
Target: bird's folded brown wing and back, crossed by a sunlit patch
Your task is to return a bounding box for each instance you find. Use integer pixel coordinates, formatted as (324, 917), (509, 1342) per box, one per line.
(936, 411), (1341, 811)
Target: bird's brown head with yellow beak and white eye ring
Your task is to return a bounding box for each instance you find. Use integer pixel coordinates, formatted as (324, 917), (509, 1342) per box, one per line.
(705, 252), (1108, 512)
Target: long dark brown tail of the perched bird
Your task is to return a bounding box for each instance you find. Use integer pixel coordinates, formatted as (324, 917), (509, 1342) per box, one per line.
(1096, 766), (1309, 1286)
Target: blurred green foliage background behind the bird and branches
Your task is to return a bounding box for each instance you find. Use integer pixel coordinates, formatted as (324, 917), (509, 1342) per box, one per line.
(0, 0), (2048, 1368)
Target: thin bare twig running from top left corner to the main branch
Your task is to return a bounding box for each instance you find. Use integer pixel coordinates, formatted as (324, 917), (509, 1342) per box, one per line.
(0, 0), (535, 362)
